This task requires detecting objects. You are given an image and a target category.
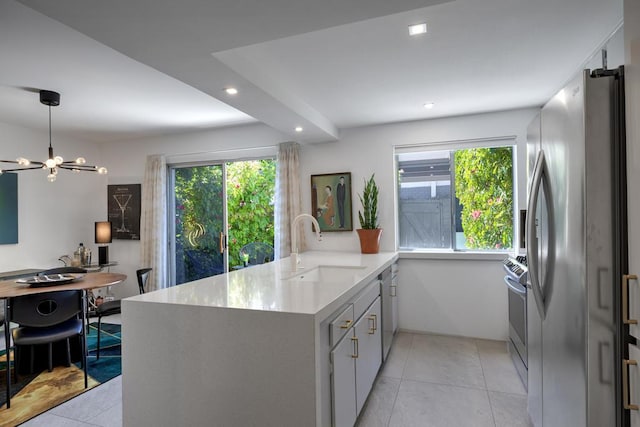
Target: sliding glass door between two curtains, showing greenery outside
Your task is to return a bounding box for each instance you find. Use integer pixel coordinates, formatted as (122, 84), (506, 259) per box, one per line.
(169, 159), (275, 285)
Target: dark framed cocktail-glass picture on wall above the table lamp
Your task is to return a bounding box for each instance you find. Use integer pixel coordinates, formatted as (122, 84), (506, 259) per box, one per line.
(107, 184), (141, 240)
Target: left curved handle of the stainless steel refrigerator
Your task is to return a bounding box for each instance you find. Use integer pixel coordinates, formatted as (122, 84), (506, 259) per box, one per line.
(526, 150), (548, 319)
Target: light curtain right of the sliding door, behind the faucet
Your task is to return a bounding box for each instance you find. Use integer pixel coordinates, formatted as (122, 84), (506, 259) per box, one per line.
(275, 142), (304, 259)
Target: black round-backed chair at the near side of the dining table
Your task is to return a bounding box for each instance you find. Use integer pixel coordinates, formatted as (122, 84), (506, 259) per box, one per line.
(7, 290), (88, 407)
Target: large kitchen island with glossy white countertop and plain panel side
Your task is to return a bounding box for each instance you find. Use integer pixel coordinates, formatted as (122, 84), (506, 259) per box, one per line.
(122, 251), (397, 426)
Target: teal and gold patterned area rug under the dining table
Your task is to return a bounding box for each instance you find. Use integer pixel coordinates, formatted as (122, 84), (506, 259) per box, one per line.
(0, 322), (122, 426)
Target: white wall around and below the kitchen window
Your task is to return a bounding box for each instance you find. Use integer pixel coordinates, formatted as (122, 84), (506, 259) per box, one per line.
(300, 109), (538, 340)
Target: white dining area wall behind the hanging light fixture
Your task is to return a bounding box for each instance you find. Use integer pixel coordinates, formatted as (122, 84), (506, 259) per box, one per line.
(0, 123), (107, 271)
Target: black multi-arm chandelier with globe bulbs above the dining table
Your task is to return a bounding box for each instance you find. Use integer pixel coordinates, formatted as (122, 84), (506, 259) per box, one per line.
(0, 90), (107, 182)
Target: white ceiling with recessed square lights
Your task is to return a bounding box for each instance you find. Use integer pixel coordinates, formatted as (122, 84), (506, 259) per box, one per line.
(0, 0), (623, 143)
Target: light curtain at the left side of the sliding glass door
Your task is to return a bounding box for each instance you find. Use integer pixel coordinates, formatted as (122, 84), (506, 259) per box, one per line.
(140, 154), (168, 291)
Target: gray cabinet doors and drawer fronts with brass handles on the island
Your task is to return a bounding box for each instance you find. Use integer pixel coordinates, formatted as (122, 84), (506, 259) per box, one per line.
(330, 280), (382, 427)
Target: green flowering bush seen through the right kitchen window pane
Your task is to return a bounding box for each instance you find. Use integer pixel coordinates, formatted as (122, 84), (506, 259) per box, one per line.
(455, 147), (513, 249)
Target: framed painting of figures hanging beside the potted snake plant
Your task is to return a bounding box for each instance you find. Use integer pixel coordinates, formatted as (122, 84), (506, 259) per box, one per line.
(311, 172), (353, 231)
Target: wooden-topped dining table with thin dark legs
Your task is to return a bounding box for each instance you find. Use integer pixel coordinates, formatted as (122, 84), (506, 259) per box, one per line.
(0, 272), (127, 410)
